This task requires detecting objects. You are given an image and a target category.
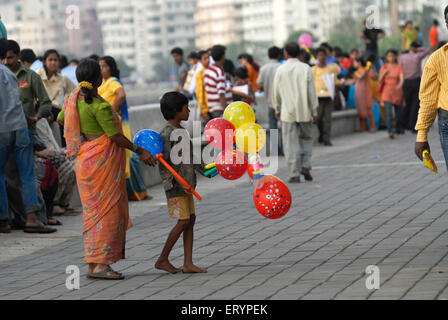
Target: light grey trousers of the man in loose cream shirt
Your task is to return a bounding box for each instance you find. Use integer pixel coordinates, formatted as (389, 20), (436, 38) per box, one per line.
(282, 121), (314, 178)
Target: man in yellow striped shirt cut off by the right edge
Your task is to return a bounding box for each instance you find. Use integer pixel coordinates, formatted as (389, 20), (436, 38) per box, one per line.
(415, 6), (448, 169)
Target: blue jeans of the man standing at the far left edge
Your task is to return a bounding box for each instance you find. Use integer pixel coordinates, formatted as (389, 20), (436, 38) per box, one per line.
(0, 129), (41, 220)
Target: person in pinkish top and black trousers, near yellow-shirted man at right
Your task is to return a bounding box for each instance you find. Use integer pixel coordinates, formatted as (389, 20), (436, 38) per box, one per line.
(400, 42), (431, 131)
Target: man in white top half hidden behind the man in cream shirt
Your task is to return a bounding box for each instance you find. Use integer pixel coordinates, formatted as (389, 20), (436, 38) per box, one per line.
(257, 46), (283, 156)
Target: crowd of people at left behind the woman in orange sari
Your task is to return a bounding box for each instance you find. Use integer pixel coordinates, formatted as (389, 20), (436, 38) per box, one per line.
(0, 39), (151, 233)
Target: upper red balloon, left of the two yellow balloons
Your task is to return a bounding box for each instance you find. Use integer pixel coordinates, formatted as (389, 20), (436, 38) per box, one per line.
(204, 118), (235, 150)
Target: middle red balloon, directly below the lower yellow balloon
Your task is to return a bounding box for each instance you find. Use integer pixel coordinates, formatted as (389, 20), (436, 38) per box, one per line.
(215, 149), (247, 180)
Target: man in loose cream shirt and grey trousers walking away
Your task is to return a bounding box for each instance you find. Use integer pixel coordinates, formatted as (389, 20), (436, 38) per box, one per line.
(272, 42), (319, 183)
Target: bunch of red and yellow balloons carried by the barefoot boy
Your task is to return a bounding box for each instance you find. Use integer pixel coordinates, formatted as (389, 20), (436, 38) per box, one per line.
(204, 101), (291, 219)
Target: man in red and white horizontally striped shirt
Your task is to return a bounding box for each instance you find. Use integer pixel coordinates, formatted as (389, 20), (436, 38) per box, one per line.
(204, 45), (232, 119)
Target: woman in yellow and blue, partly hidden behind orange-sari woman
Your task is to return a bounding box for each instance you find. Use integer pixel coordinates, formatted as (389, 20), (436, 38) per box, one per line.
(98, 56), (152, 201)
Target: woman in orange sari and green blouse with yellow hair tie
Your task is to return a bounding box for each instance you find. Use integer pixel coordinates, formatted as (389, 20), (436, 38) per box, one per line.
(58, 59), (155, 280)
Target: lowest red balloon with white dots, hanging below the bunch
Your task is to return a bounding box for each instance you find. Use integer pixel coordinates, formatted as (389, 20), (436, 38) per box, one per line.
(254, 175), (292, 219)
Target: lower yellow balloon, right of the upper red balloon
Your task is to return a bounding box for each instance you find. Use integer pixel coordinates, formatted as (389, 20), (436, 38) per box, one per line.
(236, 123), (266, 153)
